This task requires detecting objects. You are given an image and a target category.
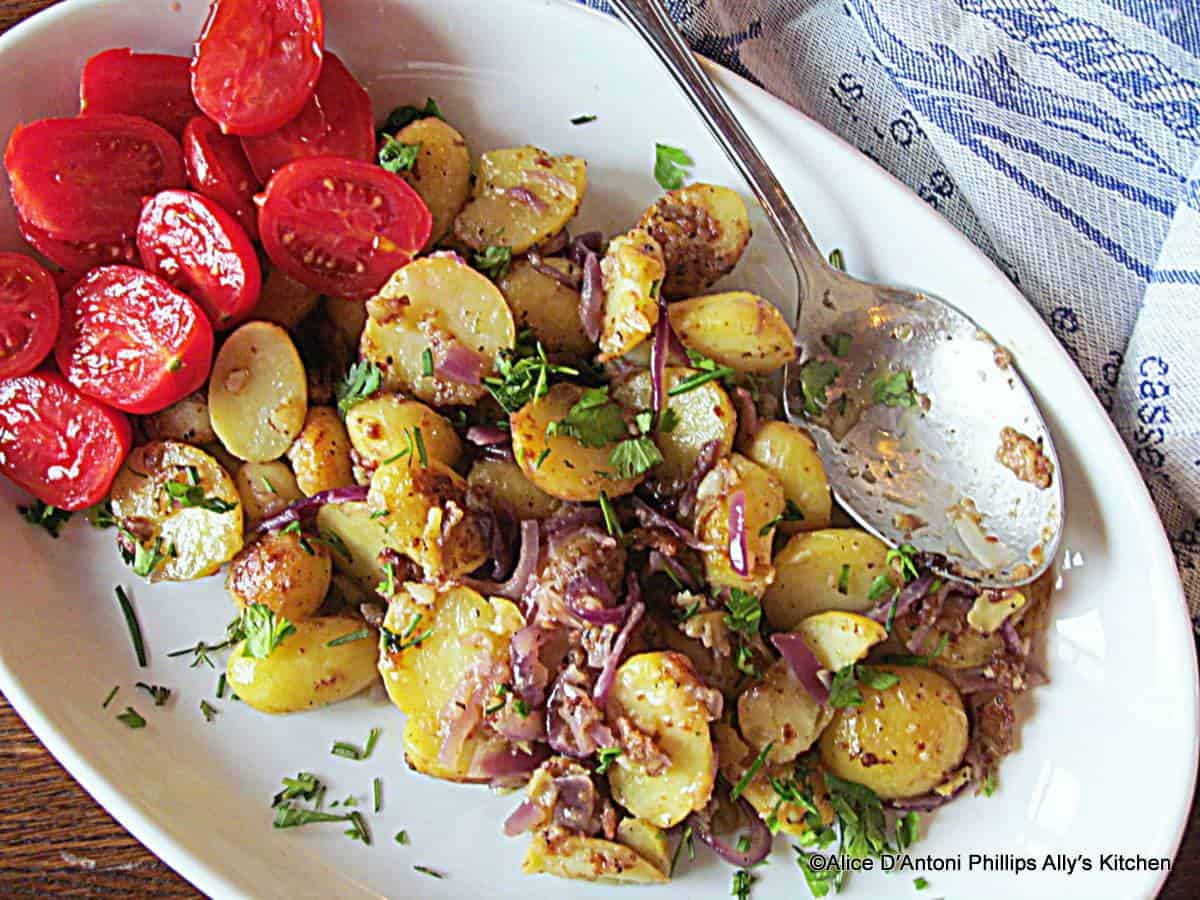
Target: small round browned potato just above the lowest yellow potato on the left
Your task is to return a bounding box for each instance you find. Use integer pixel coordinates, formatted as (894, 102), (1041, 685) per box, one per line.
(226, 532), (334, 622)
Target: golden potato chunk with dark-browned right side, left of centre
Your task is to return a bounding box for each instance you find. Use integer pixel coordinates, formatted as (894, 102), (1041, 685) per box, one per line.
(367, 458), (488, 578)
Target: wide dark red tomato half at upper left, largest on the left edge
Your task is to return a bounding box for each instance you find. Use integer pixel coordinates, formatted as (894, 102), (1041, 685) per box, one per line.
(4, 114), (186, 242)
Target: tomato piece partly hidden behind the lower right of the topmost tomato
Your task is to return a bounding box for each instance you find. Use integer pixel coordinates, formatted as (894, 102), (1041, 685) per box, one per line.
(241, 53), (376, 184)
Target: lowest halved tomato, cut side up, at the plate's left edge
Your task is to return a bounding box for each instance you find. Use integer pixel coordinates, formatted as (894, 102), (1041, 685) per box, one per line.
(0, 370), (132, 510)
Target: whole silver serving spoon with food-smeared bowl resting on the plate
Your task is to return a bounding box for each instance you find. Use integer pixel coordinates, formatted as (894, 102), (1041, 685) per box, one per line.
(610, 0), (1063, 587)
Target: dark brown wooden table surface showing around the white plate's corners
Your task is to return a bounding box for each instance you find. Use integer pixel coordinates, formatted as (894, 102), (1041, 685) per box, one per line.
(0, 0), (1200, 900)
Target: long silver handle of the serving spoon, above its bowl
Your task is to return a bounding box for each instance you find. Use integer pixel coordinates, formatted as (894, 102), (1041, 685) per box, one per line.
(608, 0), (827, 289)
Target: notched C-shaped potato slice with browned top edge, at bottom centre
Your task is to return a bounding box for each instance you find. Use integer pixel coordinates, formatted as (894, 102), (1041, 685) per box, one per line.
(607, 653), (716, 828)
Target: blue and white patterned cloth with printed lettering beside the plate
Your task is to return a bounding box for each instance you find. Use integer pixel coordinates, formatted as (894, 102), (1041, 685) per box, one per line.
(586, 0), (1200, 629)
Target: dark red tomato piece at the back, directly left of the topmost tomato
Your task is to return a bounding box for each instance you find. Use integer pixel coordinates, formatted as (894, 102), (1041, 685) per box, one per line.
(79, 47), (200, 140)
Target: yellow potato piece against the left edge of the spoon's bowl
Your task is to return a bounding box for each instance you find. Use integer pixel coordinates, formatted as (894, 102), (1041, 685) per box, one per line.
(746, 421), (833, 534)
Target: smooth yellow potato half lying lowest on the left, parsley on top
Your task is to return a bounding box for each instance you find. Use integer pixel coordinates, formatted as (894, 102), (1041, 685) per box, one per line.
(226, 616), (379, 713)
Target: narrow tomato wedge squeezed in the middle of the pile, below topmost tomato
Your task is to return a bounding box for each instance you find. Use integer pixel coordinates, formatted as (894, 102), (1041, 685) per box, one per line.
(184, 116), (263, 241)
